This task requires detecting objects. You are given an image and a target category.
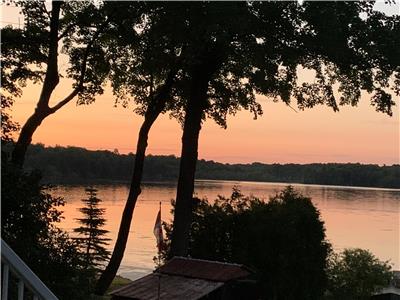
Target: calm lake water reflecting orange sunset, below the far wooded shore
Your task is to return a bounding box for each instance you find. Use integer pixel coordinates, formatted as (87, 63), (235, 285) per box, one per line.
(54, 180), (400, 279)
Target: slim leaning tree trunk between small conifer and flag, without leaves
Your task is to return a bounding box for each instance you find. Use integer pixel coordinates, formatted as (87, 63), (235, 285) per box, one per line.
(95, 70), (176, 295)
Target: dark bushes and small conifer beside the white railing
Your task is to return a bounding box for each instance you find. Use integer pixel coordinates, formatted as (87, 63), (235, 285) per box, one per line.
(1, 153), (108, 300)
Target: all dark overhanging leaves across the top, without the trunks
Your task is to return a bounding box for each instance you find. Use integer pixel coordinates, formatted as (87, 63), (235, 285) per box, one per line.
(2, 1), (400, 131)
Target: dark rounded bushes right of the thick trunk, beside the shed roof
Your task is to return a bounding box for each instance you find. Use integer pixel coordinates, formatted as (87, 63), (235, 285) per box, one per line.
(163, 186), (392, 300)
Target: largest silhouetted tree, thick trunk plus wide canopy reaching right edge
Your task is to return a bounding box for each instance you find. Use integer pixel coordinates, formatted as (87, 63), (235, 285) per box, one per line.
(171, 1), (400, 256)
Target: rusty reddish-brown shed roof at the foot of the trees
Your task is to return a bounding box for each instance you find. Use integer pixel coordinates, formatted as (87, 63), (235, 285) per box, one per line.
(110, 273), (223, 300)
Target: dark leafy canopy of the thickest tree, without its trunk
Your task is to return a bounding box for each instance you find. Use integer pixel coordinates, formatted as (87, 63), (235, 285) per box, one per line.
(145, 1), (400, 126)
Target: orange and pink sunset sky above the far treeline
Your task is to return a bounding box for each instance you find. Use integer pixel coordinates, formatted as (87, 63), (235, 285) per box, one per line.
(1, 2), (400, 164)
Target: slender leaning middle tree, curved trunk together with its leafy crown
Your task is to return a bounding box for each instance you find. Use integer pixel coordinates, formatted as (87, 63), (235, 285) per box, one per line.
(96, 3), (182, 294)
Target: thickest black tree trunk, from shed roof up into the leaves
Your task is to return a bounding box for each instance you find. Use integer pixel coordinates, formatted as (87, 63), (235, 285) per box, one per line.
(169, 42), (228, 257)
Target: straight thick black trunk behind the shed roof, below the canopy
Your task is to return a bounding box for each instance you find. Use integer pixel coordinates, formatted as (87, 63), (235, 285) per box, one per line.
(170, 68), (210, 257)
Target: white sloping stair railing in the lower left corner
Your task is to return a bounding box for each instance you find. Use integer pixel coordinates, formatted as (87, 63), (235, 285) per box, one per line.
(1, 240), (58, 300)
